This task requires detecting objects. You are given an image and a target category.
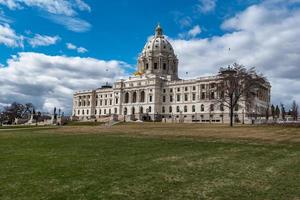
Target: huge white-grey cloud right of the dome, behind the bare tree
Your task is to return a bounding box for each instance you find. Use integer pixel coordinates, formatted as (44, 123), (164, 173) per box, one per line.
(171, 2), (300, 103)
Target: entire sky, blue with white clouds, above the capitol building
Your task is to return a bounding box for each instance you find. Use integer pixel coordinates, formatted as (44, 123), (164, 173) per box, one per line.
(0, 0), (300, 113)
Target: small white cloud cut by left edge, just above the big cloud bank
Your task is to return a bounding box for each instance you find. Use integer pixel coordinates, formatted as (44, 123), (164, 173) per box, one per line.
(0, 24), (24, 48)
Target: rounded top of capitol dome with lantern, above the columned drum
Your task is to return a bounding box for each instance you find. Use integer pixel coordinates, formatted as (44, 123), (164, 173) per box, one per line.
(142, 25), (175, 56)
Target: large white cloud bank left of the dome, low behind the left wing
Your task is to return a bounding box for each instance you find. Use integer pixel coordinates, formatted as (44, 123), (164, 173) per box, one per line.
(0, 52), (129, 112)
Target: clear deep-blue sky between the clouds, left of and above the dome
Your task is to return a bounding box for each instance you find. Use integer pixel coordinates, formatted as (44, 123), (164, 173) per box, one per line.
(0, 0), (262, 64)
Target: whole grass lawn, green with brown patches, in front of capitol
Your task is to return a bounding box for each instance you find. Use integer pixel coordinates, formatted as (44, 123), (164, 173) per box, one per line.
(0, 123), (300, 200)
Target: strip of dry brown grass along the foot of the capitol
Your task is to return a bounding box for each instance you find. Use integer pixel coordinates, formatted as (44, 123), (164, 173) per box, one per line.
(42, 123), (300, 143)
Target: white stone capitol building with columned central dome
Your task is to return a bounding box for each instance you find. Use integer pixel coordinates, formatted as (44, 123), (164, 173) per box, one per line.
(72, 25), (270, 123)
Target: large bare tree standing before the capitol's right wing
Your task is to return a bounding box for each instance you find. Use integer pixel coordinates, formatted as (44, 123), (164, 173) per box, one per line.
(217, 63), (266, 126)
